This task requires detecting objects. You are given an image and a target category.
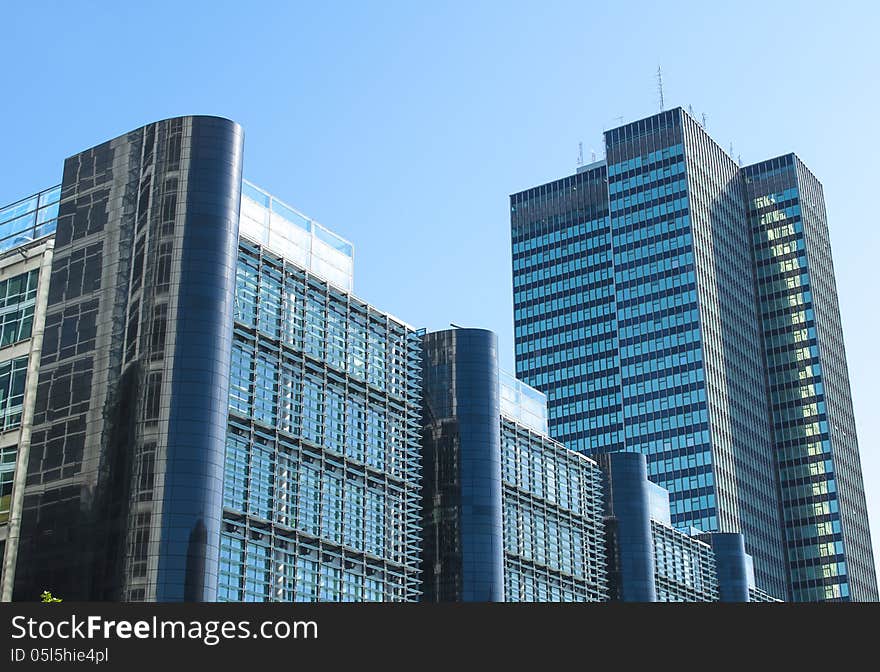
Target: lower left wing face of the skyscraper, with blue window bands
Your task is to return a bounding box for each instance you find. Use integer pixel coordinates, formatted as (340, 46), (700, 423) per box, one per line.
(510, 166), (624, 453)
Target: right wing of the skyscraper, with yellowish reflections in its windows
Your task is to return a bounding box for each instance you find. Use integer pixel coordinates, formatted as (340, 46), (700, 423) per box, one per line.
(743, 154), (877, 600)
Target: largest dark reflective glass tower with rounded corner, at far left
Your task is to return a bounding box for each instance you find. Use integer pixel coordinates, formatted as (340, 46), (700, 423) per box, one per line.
(14, 117), (242, 601)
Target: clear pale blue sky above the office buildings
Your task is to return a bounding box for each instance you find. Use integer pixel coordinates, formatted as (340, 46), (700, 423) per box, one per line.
(0, 0), (880, 576)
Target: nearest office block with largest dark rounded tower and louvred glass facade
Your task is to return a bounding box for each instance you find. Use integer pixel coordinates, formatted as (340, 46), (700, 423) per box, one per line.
(0, 117), (421, 601)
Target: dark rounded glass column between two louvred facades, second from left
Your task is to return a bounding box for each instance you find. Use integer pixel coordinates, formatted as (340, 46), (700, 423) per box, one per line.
(422, 329), (504, 602)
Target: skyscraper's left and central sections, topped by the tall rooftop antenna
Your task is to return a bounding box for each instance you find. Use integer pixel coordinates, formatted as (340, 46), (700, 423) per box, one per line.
(510, 108), (871, 599)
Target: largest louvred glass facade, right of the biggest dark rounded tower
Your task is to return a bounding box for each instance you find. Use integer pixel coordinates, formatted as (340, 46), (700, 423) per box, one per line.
(217, 238), (421, 602)
